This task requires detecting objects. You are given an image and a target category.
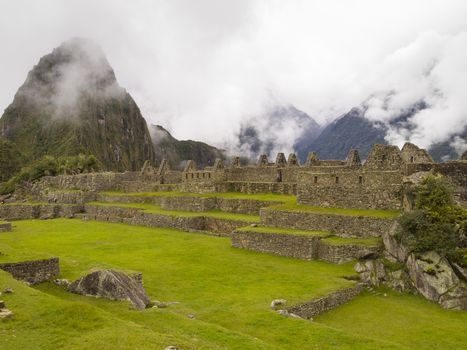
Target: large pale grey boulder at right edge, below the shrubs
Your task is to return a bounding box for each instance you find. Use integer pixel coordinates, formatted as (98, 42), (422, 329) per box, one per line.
(407, 252), (467, 309)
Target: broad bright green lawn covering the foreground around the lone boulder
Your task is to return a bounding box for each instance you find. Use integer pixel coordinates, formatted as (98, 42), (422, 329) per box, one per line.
(0, 219), (467, 350)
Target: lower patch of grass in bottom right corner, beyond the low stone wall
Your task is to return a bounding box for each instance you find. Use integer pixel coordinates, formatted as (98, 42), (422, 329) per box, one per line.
(316, 289), (467, 350)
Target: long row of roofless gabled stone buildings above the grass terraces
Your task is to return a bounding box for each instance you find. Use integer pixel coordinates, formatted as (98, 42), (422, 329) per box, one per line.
(27, 143), (467, 210)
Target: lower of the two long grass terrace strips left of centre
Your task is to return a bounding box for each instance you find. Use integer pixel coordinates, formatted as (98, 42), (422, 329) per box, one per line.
(86, 202), (260, 222)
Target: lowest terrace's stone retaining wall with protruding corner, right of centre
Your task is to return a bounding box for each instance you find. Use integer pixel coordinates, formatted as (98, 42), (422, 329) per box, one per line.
(230, 230), (378, 264)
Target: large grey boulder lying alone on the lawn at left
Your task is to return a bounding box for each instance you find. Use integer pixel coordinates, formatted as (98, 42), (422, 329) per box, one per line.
(68, 270), (151, 310)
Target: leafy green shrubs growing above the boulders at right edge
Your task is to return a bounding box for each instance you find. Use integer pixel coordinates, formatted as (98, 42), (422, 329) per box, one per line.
(399, 175), (467, 265)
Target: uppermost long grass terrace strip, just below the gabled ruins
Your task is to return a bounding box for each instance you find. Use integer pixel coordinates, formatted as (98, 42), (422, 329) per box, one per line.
(101, 191), (296, 203)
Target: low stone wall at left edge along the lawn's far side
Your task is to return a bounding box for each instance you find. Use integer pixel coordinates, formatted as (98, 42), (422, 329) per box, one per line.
(0, 203), (83, 220)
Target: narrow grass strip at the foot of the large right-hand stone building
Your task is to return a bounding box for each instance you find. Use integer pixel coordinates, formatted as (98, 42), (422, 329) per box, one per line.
(270, 203), (400, 218)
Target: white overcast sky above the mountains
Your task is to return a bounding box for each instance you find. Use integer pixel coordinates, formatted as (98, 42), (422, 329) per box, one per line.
(0, 0), (467, 150)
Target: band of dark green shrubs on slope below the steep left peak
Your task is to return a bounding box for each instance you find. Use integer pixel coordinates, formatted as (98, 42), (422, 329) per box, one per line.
(0, 154), (99, 194)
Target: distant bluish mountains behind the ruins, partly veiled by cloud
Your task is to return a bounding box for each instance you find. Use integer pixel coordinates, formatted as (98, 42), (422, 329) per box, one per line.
(236, 102), (467, 162)
